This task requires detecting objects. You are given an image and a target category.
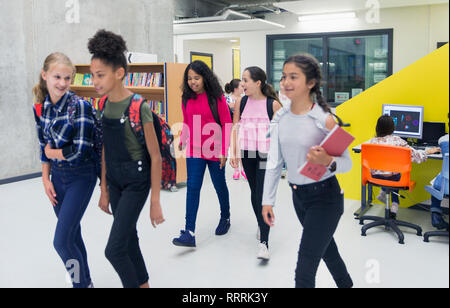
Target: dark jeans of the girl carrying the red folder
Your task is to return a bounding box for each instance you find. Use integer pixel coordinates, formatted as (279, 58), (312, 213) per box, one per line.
(291, 177), (353, 288)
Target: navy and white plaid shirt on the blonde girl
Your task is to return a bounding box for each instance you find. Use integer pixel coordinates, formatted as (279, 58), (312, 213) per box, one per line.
(33, 92), (95, 166)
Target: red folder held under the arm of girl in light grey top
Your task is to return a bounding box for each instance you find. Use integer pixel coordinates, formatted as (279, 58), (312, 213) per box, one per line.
(298, 125), (355, 181)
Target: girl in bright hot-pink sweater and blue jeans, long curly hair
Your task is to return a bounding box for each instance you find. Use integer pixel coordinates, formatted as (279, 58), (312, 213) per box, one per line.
(173, 61), (232, 247)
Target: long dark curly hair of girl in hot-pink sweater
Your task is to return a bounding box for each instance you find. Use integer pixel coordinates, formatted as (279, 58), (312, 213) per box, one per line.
(182, 60), (223, 124)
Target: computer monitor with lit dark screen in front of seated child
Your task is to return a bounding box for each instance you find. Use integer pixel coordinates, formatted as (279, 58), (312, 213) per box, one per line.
(383, 104), (423, 139)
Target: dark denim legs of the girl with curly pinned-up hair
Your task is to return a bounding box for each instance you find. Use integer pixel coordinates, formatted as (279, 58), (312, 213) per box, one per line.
(105, 162), (151, 288)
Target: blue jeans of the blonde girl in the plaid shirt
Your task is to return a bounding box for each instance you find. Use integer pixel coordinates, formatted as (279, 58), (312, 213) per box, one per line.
(51, 163), (97, 288)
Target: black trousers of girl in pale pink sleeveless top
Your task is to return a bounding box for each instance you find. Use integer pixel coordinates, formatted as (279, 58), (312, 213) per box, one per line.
(242, 151), (270, 246)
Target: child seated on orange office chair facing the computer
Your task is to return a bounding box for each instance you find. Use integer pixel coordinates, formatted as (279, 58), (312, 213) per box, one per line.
(368, 115), (440, 219)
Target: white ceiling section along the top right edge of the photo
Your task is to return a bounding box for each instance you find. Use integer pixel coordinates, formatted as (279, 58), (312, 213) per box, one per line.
(273, 0), (449, 15)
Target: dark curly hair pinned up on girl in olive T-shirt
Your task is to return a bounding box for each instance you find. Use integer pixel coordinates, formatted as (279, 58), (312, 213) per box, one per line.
(88, 29), (128, 77)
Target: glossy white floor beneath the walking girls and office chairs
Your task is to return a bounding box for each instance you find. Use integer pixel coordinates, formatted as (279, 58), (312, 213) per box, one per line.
(0, 168), (449, 288)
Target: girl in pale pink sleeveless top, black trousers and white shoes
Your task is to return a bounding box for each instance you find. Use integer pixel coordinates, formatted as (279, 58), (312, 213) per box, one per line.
(231, 66), (281, 260)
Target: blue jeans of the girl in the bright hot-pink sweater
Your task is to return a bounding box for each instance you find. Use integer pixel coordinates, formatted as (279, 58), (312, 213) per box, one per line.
(186, 158), (230, 232)
